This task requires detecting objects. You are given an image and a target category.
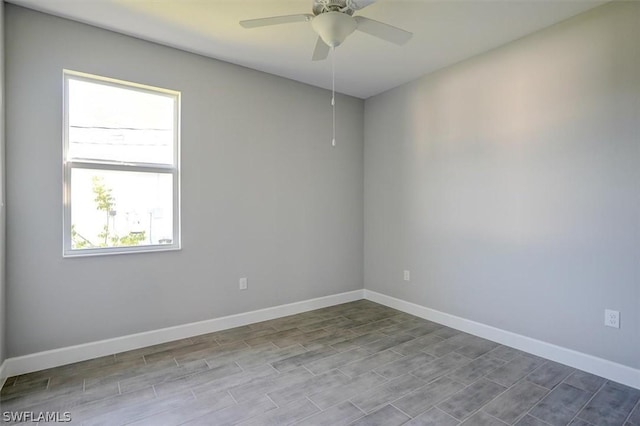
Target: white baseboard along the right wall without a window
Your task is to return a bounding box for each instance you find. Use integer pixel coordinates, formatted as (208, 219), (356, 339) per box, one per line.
(364, 290), (640, 389)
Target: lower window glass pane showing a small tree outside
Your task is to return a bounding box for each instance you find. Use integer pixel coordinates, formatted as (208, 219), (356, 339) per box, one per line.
(71, 169), (174, 250)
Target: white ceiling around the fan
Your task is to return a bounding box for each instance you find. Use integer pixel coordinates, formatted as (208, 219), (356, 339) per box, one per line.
(10, 0), (606, 98)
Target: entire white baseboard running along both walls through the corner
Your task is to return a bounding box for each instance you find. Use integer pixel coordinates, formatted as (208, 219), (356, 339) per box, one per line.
(0, 290), (640, 389)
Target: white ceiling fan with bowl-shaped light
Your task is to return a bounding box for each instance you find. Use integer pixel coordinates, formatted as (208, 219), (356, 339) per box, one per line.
(240, 0), (413, 61)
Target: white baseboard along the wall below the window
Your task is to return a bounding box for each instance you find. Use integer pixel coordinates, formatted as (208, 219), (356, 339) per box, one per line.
(0, 290), (364, 383)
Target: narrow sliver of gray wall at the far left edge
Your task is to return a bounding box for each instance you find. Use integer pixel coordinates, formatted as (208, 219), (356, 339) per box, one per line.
(0, 1), (7, 366)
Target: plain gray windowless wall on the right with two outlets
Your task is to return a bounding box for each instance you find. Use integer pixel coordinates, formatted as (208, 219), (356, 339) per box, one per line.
(364, 2), (640, 368)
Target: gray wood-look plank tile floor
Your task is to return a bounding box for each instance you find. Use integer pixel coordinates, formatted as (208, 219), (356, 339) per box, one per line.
(0, 300), (640, 426)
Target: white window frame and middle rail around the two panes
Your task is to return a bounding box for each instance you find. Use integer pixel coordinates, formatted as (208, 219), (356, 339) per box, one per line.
(62, 69), (182, 257)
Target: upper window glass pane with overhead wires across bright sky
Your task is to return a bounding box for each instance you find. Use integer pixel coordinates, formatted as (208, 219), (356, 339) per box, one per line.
(68, 78), (176, 164)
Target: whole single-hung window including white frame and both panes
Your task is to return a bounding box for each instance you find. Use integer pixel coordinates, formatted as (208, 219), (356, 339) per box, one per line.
(63, 70), (180, 256)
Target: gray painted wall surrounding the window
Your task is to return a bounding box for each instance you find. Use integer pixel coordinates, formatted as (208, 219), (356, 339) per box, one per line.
(5, 5), (364, 356)
